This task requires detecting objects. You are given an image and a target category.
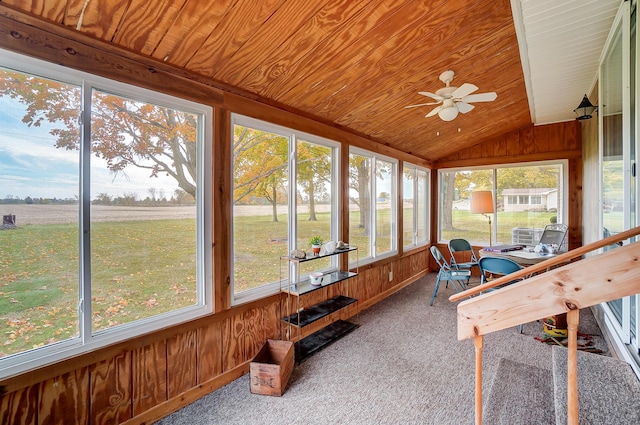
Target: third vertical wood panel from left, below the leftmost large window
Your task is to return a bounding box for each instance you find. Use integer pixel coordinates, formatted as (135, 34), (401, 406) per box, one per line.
(89, 352), (132, 424)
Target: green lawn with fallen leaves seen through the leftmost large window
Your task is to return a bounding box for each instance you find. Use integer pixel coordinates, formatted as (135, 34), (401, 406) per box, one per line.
(0, 220), (196, 357)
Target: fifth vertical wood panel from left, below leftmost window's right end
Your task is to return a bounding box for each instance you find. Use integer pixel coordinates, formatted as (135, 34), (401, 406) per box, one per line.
(167, 329), (198, 398)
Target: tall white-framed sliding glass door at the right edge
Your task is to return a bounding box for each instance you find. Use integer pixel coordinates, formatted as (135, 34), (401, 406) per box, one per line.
(598, 2), (639, 353)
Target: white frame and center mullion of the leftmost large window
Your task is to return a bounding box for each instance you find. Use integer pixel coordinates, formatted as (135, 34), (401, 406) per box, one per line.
(0, 49), (213, 379)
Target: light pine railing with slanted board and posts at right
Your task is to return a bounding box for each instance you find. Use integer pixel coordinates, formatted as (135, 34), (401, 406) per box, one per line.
(449, 227), (640, 425)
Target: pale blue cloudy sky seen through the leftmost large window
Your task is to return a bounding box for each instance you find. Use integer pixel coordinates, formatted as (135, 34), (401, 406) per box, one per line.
(0, 97), (177, 199)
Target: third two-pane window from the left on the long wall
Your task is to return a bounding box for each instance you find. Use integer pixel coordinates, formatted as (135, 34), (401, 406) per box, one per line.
(349, 148), (398, 262)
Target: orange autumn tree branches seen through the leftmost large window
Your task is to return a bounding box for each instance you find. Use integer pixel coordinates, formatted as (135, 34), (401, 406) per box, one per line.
(0, 70), (198, 198)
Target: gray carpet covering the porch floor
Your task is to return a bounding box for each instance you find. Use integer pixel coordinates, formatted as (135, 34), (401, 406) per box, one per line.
(159, 274), (606, 425)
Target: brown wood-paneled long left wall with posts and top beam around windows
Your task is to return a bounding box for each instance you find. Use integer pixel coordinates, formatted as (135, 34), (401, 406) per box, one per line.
(0, 9), (428, 425)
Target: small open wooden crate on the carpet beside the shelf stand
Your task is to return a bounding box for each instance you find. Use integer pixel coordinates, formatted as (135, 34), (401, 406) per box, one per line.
(249, 339), (294, 397)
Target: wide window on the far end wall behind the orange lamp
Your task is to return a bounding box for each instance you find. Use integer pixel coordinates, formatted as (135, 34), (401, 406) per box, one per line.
(438, 161), (566, 245)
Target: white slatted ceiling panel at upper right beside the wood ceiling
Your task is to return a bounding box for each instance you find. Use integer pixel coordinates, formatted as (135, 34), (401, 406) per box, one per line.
(511, 0), (624, 125)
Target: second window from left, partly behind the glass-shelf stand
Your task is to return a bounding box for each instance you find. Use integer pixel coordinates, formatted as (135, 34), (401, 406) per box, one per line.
(232, 115), (339, 303)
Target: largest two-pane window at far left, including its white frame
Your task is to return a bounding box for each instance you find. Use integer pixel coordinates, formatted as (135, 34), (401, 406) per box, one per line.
(0, 51), (212, 374)
